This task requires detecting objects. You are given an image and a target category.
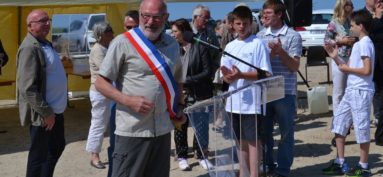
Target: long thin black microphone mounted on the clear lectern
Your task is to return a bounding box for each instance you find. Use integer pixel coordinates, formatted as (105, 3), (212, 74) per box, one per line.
(182, 31), (270, 79)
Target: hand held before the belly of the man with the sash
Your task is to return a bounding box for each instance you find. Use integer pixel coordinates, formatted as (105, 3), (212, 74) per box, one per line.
(126, 96), (154, 115)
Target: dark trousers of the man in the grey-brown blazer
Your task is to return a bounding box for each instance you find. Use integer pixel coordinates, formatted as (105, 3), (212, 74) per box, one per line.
(26, 114), (65, 177)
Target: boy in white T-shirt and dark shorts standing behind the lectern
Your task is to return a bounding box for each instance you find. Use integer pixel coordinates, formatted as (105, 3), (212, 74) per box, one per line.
(221, 6), (271, 177)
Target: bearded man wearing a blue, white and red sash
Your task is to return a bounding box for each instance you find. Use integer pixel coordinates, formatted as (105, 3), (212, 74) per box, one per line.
(95, 0), (186, 177)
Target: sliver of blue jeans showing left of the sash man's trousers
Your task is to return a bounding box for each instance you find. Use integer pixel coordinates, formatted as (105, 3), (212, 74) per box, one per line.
(108, 103), (116, 177)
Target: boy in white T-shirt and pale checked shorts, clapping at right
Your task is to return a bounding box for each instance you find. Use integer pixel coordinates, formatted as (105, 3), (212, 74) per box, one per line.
(323, 11), (375, 177)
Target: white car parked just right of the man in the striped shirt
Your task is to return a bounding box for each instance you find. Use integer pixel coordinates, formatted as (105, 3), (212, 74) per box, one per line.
(295, 9), (334, 53)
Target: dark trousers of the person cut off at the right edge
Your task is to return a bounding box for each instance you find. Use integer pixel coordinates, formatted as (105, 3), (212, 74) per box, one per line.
(373, 86), (383, 146)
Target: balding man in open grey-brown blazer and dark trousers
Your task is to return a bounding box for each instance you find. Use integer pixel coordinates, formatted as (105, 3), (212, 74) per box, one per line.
(16, 10), (67, 177)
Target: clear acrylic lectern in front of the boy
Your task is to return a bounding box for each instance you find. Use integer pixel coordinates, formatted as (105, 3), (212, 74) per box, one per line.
(185, 76), (285, 177)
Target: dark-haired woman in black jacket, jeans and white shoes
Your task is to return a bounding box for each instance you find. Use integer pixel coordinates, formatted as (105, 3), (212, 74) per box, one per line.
(171, 19), (213, 171)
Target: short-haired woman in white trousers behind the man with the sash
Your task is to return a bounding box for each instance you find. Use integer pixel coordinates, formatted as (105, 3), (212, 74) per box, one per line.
(86, 22), (114, 169)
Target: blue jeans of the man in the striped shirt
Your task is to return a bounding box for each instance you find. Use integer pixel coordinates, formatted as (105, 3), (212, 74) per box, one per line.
(262, 95), (296, 176)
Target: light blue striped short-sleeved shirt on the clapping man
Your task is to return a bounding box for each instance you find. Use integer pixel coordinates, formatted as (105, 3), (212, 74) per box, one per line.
(257, 25), (302, 95)
